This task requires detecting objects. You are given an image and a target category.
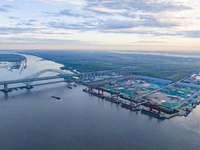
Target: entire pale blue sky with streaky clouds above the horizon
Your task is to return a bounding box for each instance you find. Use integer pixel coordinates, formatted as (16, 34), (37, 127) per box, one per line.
(0, 0), (200, 51)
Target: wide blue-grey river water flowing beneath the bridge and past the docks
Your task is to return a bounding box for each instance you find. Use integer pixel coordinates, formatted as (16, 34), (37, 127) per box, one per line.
(0, 55), (200, 150)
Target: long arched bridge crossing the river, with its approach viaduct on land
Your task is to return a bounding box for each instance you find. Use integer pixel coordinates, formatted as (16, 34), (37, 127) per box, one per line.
(0, 67), (136, 92)
